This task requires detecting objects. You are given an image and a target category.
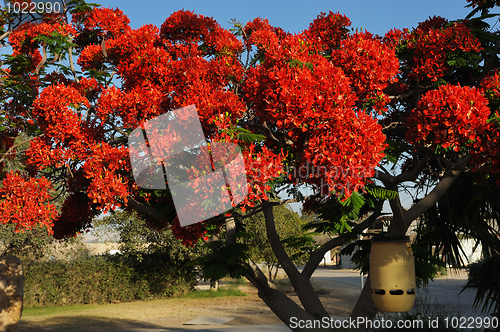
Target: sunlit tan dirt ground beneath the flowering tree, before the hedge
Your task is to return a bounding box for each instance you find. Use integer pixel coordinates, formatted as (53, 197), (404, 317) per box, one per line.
(19, 276), (359, 332)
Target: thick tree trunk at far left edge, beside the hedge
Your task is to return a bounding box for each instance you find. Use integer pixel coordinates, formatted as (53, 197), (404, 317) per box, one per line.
(0, 255), (24, 332)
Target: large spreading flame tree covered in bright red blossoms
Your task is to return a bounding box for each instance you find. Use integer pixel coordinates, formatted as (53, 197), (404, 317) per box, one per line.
(0, 0), (500, 330)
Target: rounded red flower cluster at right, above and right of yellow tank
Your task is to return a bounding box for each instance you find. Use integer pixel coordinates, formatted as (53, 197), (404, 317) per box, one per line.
(406, 84), (490, 151)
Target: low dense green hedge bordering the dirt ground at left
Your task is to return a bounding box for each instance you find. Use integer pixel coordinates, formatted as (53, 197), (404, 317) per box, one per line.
(23, 254), (196, 307)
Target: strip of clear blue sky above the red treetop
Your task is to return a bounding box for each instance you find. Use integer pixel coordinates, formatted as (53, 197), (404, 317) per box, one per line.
(99, 0), (470, 34)
